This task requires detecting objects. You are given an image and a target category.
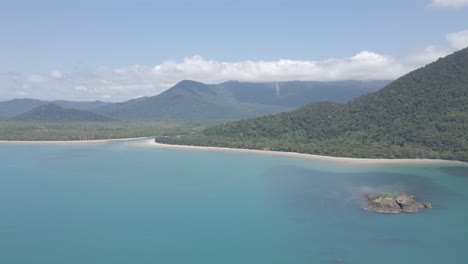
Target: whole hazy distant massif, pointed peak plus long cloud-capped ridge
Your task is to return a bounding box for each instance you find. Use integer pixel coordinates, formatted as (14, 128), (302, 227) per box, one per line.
(93, 80), (388, 122)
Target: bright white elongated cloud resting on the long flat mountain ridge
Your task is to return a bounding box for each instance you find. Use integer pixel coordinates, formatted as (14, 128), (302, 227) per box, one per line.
(154, 51), (408, 85)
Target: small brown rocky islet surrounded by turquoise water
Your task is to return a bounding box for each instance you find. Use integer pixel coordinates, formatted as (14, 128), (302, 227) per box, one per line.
(365, 193), (432, 214)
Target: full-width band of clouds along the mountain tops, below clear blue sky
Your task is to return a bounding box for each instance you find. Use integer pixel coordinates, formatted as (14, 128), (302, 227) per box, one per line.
(0, 30), (468, 101)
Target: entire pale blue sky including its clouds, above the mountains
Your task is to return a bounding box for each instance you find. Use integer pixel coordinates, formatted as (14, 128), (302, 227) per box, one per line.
(0, 0), (468, 102)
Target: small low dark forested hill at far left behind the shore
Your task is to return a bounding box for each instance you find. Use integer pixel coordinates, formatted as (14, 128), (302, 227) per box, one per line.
(9, 103), (112, 123)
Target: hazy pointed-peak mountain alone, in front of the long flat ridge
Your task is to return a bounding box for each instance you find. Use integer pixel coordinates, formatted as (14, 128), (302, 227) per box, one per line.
(95, 81), (289, 122)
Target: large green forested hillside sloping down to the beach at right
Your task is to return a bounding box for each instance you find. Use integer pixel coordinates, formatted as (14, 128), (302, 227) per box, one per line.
(158, 48), (468, 161)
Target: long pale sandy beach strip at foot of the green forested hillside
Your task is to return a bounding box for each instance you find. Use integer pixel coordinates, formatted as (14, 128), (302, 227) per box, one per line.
(130, 139), (468, 165)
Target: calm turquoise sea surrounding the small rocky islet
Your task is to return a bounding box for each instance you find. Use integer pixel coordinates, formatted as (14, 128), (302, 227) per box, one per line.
(0, 142), (468, 264)
